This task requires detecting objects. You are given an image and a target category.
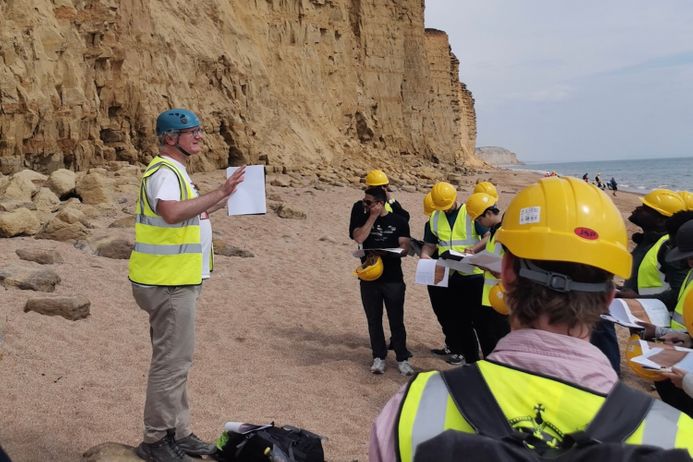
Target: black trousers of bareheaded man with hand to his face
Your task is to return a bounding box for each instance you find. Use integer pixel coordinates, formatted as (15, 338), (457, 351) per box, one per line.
(361, 281), (411, 361)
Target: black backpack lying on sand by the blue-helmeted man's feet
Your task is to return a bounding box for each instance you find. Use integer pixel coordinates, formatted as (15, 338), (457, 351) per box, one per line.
(214, 422), (325, 462)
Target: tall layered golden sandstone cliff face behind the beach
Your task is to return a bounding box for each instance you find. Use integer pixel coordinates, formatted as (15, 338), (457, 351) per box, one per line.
(0, 0), (478, 174)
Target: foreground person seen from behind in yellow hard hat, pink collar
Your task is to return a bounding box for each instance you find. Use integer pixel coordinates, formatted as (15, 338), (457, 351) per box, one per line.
(369, 177), (693, 462)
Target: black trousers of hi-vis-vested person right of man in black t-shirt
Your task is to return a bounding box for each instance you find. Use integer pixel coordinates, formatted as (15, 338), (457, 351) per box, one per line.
(429, 273), (484, 362)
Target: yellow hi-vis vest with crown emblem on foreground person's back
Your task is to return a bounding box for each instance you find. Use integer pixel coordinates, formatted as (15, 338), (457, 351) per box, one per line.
(395, 361), (693, 462)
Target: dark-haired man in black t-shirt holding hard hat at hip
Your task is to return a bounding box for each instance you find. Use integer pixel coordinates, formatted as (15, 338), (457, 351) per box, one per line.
(349, 185), (414, 375)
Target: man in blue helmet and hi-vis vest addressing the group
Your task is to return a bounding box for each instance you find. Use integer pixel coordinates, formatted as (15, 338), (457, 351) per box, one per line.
(128, 109), (244, 462)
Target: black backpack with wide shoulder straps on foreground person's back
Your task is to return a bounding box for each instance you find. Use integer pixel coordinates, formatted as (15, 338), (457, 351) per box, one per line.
(414, 365), (691, 462)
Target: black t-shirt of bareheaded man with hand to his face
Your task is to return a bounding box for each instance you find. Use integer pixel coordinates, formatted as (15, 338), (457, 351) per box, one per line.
(349, 213), (410, 282)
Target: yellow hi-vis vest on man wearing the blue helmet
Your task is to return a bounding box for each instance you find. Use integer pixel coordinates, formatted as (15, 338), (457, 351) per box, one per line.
(128, 156), (203, 286)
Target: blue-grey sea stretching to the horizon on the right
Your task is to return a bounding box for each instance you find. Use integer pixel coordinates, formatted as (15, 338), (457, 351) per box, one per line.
(505, 157), (693, 194)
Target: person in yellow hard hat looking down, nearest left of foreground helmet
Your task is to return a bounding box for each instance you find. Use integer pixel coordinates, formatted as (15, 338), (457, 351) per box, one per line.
(465, 193), (510, 357)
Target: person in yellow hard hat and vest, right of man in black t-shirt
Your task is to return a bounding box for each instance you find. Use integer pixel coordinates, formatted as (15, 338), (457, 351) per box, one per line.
(421, 181), (484, 364)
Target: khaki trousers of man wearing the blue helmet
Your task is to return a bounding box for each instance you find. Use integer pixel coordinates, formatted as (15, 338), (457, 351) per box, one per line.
(132, 284), (202, 443)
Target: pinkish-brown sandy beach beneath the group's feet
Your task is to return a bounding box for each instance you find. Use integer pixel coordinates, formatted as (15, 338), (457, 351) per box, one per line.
(0, 170), (645, 462)
